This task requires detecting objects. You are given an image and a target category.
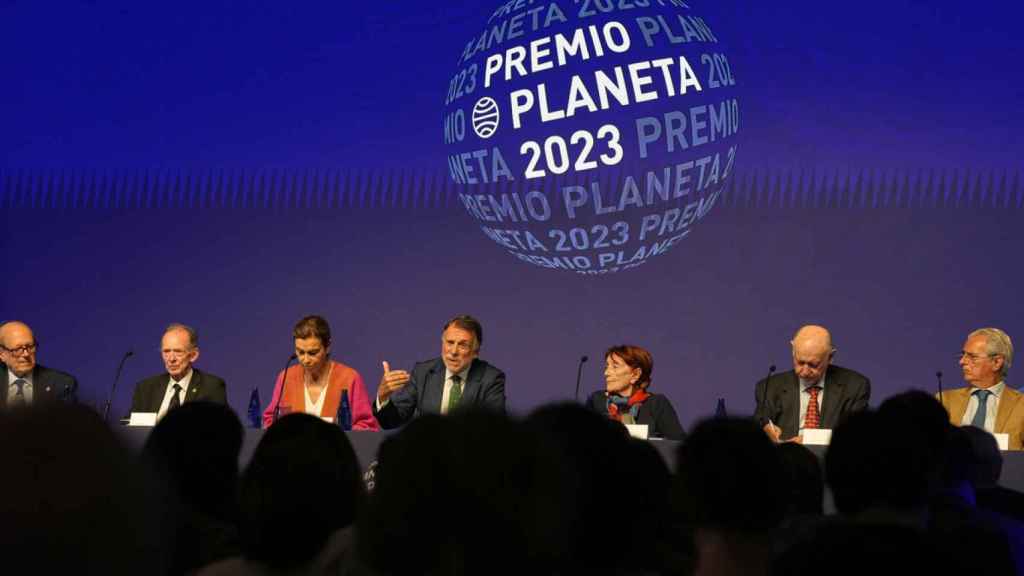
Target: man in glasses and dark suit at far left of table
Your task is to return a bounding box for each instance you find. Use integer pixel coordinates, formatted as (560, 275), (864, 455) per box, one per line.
(0, 322), (78, 408)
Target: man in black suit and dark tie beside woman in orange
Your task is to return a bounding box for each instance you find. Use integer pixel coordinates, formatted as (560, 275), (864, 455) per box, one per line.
(131, 324), (227, 418)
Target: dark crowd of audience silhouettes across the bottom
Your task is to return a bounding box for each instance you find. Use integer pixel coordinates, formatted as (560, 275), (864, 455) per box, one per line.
(0, 390), (1024, 576)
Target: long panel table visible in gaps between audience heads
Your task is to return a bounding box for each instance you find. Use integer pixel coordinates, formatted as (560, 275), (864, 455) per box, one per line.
(118, 426), (1024, 492)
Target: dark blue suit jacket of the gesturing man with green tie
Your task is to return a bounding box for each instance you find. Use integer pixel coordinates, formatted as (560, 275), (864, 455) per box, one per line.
(373, 358), (505, 428)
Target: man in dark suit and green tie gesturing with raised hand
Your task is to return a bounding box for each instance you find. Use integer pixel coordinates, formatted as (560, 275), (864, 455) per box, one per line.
(374, 316), (505, 428)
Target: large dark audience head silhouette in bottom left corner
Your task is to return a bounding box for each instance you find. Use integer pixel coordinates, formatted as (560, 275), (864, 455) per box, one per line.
(0, 404), (173, 574)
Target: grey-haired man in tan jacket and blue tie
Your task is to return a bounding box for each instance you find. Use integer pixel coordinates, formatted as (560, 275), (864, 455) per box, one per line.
(940, 328), (1024, 450)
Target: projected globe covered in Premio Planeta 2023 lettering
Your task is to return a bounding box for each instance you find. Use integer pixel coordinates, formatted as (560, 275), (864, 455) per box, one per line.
(443, 0), (739, 275)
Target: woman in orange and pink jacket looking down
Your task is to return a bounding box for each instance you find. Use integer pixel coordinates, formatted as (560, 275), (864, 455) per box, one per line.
(263, 316), (380, 430)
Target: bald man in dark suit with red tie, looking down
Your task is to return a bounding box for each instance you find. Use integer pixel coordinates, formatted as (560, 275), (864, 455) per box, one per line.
(754, 325), (871, 442)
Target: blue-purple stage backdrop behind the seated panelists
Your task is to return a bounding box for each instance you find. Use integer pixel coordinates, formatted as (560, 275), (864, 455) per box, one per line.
(0, 0), (1024, 425)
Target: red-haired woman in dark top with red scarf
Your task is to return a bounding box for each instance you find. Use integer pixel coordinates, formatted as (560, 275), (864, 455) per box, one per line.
(587, 344), (686, 440)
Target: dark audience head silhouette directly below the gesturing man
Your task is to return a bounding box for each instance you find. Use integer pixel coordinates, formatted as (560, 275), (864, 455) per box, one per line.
(357, 411), (537, 575)
